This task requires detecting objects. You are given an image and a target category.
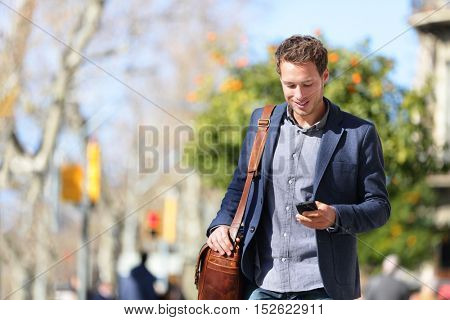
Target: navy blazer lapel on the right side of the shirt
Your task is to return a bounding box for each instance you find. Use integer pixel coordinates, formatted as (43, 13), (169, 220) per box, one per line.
(313, 102), (344, 199)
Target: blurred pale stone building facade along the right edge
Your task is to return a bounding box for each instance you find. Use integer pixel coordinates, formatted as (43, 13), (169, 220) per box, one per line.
(409, 0), (450, 278)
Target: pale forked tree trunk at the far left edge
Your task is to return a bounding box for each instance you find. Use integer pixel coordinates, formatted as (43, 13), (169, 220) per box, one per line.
(0, 0), (104, 299)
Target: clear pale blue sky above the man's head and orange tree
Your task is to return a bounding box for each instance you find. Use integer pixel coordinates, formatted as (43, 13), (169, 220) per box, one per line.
(244, 0), (418, 87)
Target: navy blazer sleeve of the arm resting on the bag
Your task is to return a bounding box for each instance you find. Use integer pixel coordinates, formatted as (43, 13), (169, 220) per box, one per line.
(206, 108), (262, 236)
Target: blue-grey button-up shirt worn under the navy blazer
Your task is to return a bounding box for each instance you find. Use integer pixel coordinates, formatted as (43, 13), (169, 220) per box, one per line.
(255, 100), (329, 292)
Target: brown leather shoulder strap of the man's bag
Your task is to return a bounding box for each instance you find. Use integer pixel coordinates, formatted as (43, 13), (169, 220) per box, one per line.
(230, 105), (275, 243)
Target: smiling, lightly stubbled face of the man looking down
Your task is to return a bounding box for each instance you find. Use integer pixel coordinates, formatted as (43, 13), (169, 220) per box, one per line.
(280, 61), (328, 126)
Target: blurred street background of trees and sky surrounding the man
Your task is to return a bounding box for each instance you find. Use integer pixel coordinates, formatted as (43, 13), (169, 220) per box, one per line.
(0, 0), (450, 299)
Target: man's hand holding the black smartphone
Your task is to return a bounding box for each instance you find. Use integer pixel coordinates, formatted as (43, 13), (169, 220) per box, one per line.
(295, 201), (336, 230)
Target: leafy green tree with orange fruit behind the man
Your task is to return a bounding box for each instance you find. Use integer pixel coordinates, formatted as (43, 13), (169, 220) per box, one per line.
(185, 42), (442, 267)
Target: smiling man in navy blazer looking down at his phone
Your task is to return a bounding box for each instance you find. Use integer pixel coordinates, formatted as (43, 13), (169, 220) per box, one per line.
(207, 35), (390, 299)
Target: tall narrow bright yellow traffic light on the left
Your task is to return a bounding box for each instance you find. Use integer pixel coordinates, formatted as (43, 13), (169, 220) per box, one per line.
(86, 141), (101, 204)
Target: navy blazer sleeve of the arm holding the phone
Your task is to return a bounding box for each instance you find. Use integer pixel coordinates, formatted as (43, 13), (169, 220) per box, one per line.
(333, 124), (391, 233)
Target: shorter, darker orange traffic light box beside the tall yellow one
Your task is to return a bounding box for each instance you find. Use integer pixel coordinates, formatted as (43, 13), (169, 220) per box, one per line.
(60, 164), (83, 203)
